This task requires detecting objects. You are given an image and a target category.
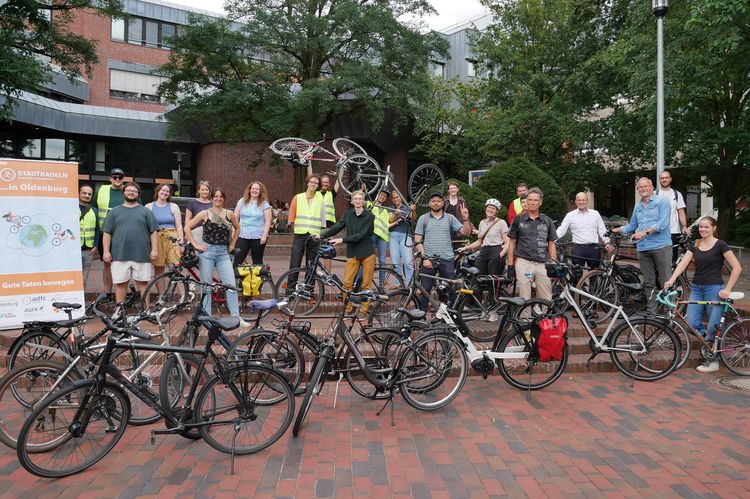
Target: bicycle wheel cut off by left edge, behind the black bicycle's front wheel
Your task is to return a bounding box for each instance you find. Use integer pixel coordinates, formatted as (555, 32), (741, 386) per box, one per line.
(0, 360), (80, 449)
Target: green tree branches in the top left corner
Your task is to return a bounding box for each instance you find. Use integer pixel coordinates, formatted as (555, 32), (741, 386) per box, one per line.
(0, 0), (123, 120)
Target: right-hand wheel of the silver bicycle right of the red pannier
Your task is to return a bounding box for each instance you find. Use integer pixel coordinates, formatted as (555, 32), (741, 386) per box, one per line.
(609, 317), (681, 381)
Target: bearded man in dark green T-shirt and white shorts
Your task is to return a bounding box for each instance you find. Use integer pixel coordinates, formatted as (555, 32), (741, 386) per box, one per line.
(102, 182), (159, 303)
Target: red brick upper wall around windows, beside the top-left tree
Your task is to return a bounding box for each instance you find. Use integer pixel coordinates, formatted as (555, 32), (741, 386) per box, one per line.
(69, 11), (169, 113)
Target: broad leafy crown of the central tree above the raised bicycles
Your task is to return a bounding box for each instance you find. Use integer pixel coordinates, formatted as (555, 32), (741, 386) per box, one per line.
(160, 0), (447, 141)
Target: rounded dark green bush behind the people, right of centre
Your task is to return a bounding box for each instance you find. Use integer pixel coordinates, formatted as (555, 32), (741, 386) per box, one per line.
(477, 158), (567, 221)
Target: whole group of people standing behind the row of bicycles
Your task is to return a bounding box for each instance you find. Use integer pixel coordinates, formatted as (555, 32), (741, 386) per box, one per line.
(79, 166), (741, 372)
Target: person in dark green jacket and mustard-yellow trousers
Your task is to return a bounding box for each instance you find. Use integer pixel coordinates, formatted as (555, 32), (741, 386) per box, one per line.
(320, 191), (375, 312)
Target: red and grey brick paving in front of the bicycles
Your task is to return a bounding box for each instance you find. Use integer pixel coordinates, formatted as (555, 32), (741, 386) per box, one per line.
(0, 370), (750, 499)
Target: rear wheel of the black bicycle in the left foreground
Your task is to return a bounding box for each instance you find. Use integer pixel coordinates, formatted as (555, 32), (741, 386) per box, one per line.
(195, 363), (294, 454)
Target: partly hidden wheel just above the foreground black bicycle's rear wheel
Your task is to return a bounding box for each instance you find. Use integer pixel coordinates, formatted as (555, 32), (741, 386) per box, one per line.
(227, 329), (305, 390)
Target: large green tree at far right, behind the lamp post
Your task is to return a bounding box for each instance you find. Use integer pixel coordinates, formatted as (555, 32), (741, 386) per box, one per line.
(597, 0), (750, 239)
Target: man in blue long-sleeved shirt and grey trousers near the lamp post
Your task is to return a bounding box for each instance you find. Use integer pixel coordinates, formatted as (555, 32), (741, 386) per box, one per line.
(613, 177), (672, 314)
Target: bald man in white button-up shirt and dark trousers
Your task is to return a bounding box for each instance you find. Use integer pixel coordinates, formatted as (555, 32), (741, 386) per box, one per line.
(557, 192), (612, 269)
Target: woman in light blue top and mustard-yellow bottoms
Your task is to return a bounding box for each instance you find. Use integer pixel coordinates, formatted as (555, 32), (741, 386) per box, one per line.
(146, 184), (184, 292)
